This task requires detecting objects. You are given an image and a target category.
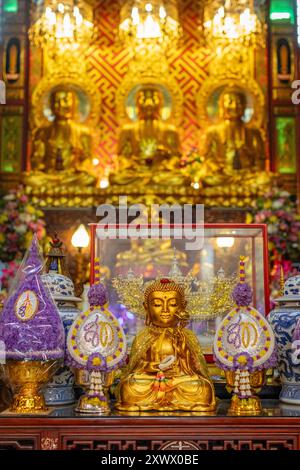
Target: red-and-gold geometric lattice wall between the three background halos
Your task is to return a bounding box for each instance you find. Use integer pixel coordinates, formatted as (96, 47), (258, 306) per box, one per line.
(88, 0), (210, 165)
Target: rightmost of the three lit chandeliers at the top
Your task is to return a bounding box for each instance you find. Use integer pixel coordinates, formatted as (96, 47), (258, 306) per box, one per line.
(203, 0), (264, 47)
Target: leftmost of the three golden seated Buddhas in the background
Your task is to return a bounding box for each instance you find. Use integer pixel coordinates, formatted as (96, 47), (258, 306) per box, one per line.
(25, 88), (95, 186)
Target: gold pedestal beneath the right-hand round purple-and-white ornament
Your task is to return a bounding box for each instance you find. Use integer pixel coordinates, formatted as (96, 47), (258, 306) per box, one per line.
(225, 370), (266, 416)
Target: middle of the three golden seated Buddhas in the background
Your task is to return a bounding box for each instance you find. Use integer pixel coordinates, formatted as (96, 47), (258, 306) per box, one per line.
(110, 85), (183, 185)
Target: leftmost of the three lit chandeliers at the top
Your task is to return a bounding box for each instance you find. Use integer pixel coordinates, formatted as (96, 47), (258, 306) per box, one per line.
(29, 0), (94, 52)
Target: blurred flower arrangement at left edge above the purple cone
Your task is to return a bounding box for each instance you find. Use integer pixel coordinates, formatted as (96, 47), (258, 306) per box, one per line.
(0, 186), (46, 295)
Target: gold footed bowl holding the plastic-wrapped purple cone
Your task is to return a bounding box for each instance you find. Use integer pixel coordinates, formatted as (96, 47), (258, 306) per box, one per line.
(5, 359), (60, 414)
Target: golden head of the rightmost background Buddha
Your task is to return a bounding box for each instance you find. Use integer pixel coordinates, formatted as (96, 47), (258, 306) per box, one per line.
(219, 87), (247, 121)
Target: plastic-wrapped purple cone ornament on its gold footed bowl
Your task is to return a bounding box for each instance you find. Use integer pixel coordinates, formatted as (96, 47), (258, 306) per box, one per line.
(0, 236), (64, 413)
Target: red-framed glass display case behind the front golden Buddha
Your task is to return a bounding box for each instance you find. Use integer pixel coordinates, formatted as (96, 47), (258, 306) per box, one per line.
(90, 224), (270, 362)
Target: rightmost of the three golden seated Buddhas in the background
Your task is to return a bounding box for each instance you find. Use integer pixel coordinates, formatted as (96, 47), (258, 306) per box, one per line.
(197, 86), (269, 186)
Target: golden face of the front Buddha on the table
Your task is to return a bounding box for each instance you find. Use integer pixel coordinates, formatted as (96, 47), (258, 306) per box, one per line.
(146, 291), (184, 327)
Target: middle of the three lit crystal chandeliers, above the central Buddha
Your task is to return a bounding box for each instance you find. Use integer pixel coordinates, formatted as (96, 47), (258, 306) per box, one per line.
(119, 0), (180, 52)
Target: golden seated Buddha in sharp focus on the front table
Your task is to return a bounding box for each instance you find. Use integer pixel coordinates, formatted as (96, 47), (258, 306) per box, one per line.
(115, 279), (216, 412)
